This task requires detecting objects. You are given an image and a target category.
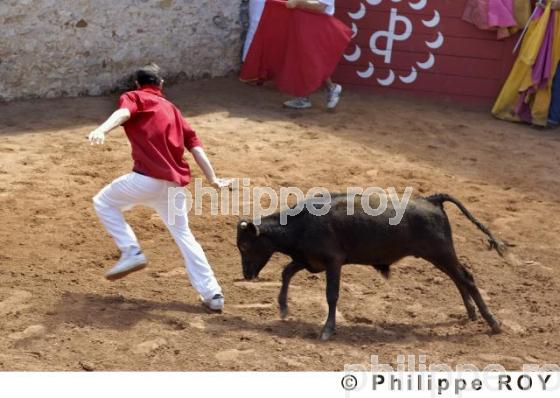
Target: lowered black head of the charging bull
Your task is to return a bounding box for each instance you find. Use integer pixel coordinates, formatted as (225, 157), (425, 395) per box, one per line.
(237, 221), (274, 280)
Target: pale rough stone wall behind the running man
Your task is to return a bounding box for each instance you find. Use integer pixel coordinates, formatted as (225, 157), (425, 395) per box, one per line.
(0, 0), (243, 101)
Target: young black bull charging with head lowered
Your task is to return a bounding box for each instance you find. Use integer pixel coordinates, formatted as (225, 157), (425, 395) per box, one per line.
(237, 194), (506, 340)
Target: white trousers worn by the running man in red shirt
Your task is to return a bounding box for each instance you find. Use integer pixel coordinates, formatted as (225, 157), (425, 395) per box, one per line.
(93, 173), (222, 299)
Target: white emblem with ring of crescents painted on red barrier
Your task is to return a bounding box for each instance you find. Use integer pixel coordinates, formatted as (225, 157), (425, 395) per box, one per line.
(344, 0), (445, 87)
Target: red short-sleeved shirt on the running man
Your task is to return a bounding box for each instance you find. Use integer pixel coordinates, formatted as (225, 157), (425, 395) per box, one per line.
(119, 86), (202, 186)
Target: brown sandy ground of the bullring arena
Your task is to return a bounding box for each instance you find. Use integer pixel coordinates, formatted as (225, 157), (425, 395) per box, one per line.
(0, 79), (560, 370)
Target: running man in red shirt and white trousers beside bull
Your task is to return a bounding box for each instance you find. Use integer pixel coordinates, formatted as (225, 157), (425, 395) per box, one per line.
(89, 64), (230, 311)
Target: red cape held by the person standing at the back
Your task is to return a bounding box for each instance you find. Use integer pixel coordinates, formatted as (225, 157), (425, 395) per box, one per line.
(240, 0), (352, 97)
